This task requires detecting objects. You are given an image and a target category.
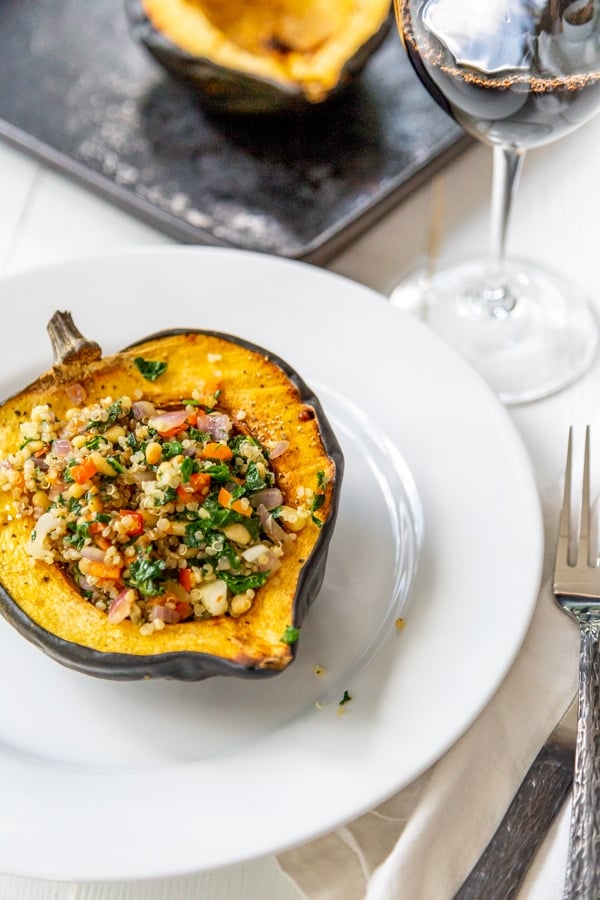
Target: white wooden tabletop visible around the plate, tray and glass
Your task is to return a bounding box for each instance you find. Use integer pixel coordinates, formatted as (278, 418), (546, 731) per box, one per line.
(0, 107), (600, 900)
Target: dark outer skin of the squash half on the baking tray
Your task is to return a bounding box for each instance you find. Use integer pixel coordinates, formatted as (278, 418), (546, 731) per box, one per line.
(126, 0), (392, 116)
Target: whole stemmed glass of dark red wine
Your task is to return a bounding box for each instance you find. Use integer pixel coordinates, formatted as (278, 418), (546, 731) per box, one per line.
(391, 0), (600, 403)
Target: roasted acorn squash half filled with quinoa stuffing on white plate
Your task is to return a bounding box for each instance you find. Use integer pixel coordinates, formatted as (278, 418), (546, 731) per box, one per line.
(0, 313), (343, 681)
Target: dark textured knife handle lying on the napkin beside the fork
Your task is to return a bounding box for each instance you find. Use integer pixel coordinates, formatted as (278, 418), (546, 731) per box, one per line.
(454, 743), (575, 900)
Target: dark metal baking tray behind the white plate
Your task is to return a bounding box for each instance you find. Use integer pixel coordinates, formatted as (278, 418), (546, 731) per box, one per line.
(0, 0), (467, 263)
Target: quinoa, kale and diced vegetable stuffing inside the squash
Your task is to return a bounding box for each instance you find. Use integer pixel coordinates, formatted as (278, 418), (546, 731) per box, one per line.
(0, 396), (314, 635)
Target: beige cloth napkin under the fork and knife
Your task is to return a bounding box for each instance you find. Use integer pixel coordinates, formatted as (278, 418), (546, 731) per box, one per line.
(278, 491), (579, 900)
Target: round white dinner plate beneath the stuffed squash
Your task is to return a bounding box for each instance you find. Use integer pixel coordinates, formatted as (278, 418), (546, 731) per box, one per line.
(0, 247), (542, 881)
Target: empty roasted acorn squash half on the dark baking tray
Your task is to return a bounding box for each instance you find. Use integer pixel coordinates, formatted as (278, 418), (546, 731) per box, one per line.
(127, 0), (390, 113)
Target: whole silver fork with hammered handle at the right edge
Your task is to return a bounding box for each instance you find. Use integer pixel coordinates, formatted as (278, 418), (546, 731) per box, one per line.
(554, 426), (600, 900)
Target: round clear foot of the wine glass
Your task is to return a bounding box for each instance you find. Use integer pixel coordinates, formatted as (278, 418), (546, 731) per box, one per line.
(390, 259), (598, 405)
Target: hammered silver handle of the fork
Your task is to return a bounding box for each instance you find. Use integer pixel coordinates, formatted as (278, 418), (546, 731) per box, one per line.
(564, 621), (600, 900)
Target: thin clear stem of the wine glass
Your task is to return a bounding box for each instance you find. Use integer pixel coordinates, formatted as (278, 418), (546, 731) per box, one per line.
(468, 146), (525, 319)
